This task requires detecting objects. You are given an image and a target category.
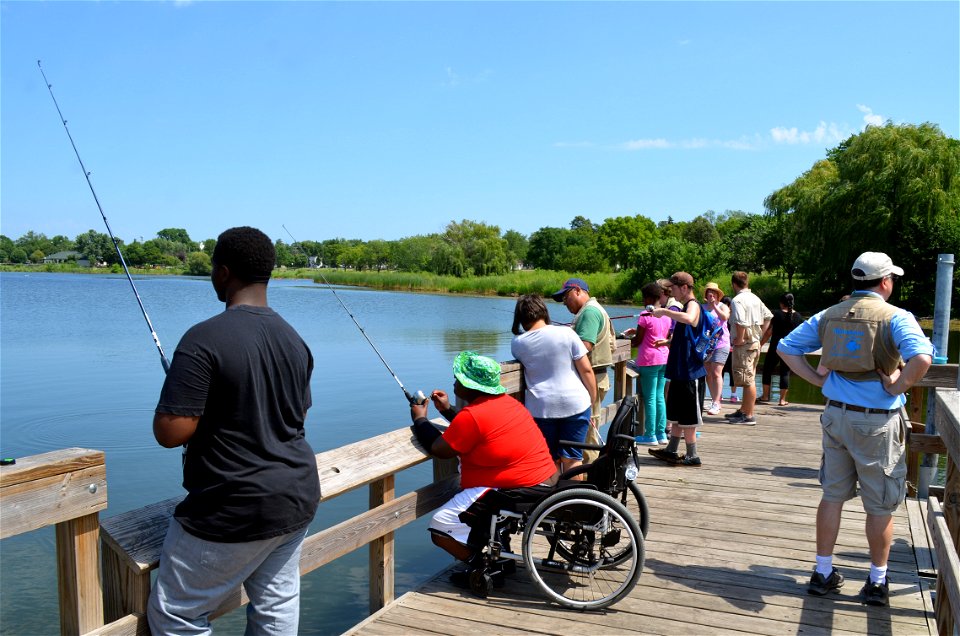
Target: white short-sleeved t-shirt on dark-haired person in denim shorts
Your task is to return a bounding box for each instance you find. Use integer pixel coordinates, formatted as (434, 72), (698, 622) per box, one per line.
(510, 325), (590, 417)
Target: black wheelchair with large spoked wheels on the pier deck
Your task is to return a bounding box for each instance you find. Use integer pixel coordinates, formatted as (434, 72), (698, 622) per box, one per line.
(460, 396), (649, 610)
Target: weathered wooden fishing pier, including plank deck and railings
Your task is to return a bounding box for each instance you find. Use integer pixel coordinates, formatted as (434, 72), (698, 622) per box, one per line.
(0, 341), (960, 636)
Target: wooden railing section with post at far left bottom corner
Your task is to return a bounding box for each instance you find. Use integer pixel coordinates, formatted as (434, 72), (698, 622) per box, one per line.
(0, 448), (107, 636)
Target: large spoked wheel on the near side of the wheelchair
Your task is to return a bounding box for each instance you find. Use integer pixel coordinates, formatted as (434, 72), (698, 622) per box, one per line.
(523, 488), (644, 609)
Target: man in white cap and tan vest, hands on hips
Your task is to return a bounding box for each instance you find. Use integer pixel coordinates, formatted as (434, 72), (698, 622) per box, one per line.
(777, 252), (933, 606)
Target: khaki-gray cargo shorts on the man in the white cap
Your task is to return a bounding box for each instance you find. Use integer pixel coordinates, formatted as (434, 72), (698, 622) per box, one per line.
(820, 406), (907, 515)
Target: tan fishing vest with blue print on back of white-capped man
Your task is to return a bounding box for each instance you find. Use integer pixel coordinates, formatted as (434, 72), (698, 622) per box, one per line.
(819, 295), (903, 382)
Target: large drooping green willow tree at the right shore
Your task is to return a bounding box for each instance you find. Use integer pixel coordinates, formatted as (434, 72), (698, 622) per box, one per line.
(765, 123), (960, 311)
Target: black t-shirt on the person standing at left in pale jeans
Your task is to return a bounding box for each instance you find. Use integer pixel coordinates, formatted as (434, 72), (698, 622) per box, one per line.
(156, 305), (320, 542)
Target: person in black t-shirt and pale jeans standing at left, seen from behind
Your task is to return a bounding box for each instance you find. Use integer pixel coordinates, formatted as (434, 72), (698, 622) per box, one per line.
(147, 227), (320, 635)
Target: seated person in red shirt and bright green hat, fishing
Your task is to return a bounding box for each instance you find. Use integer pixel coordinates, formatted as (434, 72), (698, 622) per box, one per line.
(410, 351), (559, 585)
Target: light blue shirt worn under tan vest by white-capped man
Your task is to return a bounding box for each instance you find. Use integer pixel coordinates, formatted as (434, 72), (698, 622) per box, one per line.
(777, 291), (933, 409)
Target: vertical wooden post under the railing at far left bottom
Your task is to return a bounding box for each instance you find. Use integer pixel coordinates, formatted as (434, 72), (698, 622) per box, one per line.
(56, 512), (103, 636)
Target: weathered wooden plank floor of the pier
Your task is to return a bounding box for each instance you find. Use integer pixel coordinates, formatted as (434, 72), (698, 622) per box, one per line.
(349, 405), (936, 635)
